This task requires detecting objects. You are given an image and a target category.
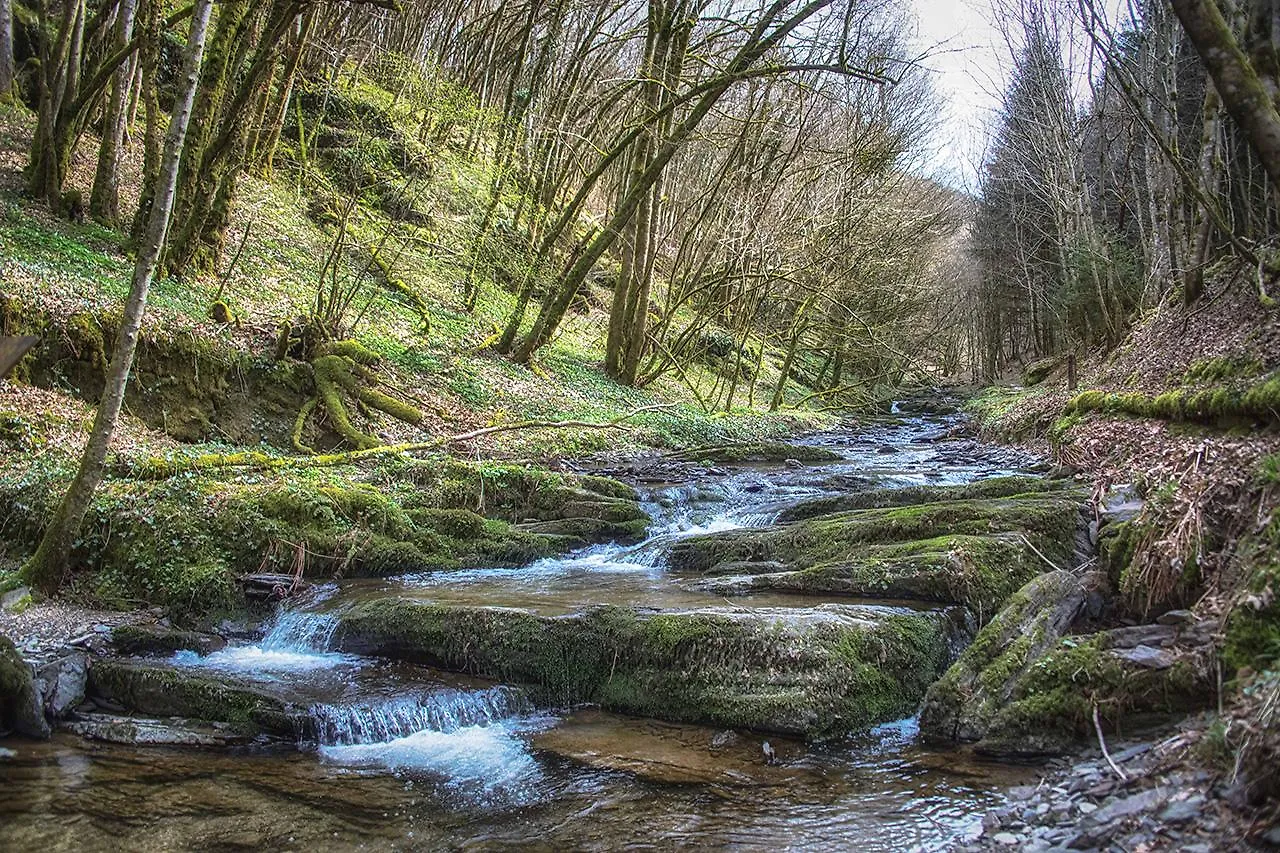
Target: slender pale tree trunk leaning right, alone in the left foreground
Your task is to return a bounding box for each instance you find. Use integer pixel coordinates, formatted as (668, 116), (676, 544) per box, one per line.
(23, 0), (212, 590)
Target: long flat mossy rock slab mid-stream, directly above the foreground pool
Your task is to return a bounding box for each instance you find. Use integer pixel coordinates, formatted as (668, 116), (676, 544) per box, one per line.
(334, 598), (951, 738)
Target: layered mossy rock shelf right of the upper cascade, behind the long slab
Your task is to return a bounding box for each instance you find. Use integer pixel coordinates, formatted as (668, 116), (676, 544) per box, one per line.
(669, 483), (1080, 616)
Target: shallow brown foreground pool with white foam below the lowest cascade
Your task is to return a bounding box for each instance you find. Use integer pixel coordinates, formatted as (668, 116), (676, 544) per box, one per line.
(0, 712), (1029, 852)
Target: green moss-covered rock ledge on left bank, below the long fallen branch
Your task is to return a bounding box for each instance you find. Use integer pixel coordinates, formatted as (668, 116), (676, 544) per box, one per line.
(0, 450), (649, 624)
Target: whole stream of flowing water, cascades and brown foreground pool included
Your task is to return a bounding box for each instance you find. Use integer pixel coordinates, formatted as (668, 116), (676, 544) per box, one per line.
(0, 409), (1049, 850)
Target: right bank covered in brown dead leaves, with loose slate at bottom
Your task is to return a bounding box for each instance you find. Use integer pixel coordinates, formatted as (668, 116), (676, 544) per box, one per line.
(966, 272), (1280, 850)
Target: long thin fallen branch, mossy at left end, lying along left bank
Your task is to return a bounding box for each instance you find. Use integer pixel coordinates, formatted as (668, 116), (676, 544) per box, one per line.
(119, 403), (675, 480)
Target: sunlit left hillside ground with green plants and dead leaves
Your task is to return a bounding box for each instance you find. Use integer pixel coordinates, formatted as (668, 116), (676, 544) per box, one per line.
(0, 79), (839, 612)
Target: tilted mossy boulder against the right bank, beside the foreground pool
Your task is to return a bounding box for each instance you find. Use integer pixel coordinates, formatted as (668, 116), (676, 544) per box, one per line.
(920, 571), (1213, 757)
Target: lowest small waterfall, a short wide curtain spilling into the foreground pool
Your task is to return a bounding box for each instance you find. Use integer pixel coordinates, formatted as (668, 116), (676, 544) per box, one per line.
(311, 686), (531, 745)
